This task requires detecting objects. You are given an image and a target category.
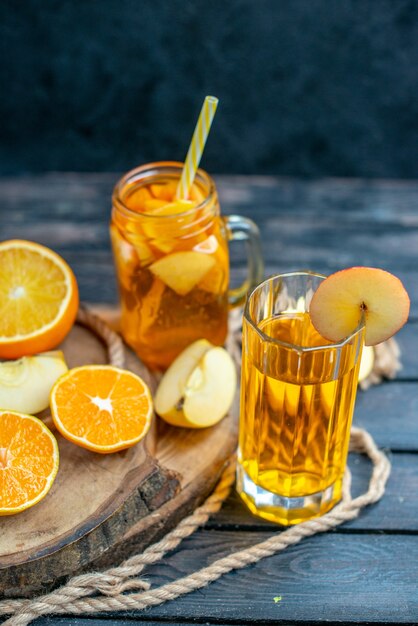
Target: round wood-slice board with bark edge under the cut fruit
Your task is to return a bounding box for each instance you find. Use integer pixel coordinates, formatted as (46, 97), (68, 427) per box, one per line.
(0, 310), (239, 597)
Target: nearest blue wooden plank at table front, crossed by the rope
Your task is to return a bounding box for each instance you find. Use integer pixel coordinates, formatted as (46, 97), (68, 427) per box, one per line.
(32, 530), (418, 625)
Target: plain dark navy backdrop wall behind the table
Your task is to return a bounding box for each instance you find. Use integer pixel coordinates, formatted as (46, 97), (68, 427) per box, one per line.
(0, 0), (418, 178)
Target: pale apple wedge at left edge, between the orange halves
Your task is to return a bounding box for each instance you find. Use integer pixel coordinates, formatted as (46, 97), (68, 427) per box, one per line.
(0, 350), (68, 415)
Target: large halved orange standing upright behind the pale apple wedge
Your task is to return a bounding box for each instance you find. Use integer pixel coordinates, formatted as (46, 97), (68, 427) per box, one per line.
(0, 239), (78, 359)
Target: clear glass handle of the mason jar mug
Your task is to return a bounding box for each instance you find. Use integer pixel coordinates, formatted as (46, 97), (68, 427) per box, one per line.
(223, 215), (264, 308)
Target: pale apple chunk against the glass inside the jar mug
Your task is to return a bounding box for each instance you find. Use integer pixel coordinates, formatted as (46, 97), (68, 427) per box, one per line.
(149, 251), (215, 296)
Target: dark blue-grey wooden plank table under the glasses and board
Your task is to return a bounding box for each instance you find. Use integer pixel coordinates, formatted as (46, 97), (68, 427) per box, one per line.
(0, 174), (418, 626)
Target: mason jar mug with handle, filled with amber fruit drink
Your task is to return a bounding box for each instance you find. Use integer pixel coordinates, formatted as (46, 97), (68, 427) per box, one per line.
(110, 162), (263, 370)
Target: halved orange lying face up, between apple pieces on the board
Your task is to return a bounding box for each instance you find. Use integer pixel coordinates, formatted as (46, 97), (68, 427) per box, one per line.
(50, 365), (153, 454)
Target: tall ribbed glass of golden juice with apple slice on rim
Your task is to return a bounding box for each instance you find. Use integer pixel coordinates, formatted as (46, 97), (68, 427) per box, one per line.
(237, 272), (364, 526)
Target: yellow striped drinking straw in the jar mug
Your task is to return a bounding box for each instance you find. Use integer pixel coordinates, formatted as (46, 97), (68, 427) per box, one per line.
(176, 96), (218, 200)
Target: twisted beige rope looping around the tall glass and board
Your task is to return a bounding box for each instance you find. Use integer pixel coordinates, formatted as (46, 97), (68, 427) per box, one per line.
(0, 313), (396, 626)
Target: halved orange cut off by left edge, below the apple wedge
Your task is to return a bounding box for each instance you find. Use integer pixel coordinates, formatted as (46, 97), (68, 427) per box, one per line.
(0, 411), (59, 515)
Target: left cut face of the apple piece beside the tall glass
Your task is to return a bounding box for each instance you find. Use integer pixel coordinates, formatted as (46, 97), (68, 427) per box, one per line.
(154, 339), (212, 426)
